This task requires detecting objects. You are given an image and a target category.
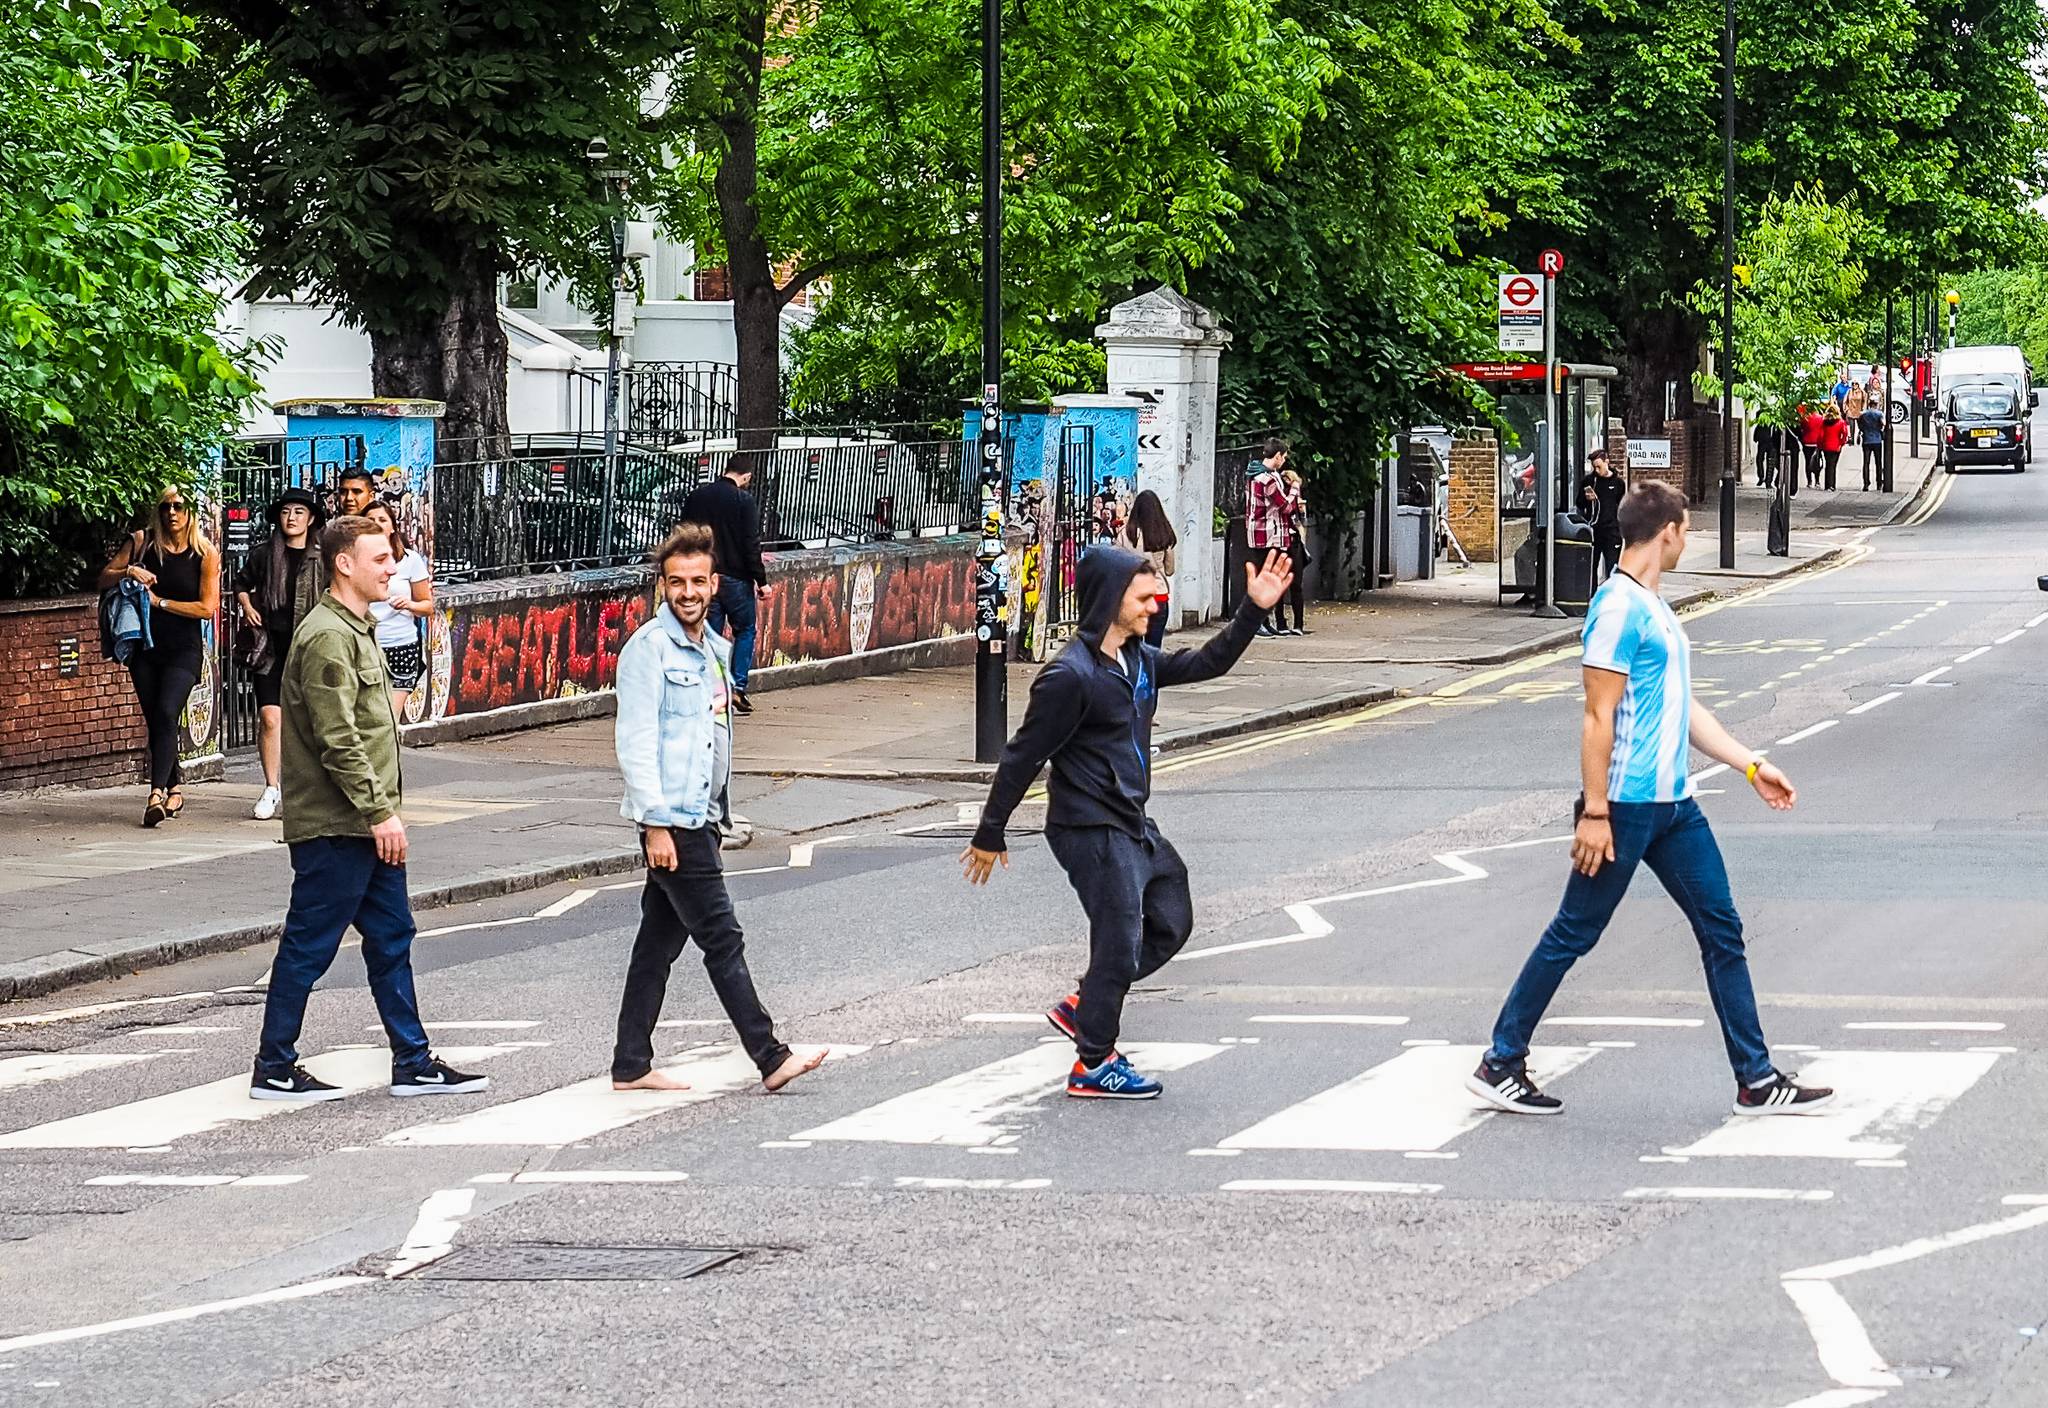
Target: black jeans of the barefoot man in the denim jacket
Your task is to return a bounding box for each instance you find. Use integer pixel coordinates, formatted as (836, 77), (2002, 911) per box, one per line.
(612, 827), (788, 1081)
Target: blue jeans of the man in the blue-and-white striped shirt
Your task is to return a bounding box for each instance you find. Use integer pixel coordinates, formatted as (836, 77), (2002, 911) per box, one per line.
(1487, 800), (1772, 1085)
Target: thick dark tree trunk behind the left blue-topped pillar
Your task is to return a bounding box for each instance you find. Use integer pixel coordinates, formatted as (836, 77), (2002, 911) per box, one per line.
(371, 247), (512, 463)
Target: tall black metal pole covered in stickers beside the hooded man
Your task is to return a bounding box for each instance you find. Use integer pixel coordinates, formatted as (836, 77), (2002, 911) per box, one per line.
(975, 0), (1010, 763)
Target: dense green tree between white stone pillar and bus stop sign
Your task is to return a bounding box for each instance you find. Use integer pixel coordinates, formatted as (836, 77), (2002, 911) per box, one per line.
(1188, 0), (1554, 510)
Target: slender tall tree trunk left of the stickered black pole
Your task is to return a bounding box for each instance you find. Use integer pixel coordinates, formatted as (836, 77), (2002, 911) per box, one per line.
(713, 0), (782, 462)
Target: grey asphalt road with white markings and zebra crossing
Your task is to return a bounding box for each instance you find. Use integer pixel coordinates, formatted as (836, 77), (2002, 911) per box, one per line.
(0, 446), (2048, 1408)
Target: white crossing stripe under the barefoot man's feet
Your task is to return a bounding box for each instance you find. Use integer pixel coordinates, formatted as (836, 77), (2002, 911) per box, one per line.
(381, 1046), (868, 1148)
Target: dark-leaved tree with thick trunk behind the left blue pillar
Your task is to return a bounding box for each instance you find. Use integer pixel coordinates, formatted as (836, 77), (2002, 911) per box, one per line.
(193, 0), (688, 452)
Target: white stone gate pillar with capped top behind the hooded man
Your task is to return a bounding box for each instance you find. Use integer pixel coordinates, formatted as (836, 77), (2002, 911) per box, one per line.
(1096, 289), (1231, 624)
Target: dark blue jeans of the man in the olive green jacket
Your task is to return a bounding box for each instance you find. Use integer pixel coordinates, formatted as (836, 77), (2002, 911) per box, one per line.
(256, 837), (428, 1074)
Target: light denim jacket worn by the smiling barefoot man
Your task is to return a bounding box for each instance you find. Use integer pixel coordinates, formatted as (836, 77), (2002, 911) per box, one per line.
(612, 602), (733, 827)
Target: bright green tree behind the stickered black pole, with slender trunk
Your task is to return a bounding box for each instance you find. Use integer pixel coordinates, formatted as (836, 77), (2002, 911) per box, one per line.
(666, 0), (1327, 442)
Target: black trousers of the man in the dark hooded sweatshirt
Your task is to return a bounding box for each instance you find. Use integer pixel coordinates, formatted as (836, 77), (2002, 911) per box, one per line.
(1044, 821), (1194, 1066)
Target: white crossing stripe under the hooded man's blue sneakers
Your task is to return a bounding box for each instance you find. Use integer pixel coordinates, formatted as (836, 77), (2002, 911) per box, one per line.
(791, 1042), (1233, 1148)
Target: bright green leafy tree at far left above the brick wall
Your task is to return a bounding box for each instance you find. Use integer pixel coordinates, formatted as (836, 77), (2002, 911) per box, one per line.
(0, 0), (256, 596)
